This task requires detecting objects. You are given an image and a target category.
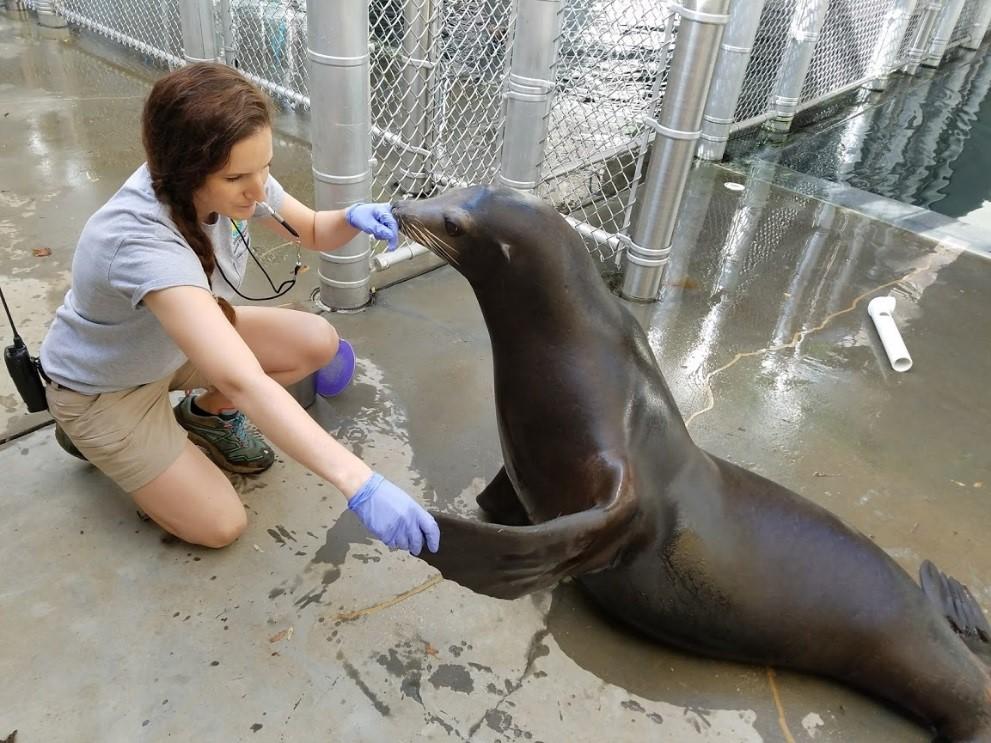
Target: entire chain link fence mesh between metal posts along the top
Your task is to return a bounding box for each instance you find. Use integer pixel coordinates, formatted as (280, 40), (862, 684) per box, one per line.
(24, 0), (991, 276)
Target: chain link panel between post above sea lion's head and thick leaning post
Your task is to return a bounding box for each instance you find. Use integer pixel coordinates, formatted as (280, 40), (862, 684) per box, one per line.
(537, 0), (675, 260)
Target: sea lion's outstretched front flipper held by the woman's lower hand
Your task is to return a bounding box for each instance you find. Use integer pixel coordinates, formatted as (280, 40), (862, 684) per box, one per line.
(420, 479), (642, 599)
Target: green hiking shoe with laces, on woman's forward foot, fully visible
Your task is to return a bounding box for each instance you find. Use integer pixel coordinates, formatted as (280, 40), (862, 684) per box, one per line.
(173, 395), (275, 475)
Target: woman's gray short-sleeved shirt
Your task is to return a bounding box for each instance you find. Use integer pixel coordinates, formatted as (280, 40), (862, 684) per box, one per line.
(40, 164), (285, 395)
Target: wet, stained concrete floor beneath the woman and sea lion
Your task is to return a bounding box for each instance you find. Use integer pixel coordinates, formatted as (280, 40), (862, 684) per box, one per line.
(0, 5), (991, 743)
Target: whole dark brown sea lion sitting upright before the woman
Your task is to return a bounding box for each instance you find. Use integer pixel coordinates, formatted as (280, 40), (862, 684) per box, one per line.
(393, 186), (991, 743)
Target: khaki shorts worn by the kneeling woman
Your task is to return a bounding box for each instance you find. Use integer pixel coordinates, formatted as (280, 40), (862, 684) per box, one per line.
(46, 361), (209, 493)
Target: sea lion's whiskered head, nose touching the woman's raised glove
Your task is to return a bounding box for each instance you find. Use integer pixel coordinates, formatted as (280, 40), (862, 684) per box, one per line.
(392, 185), (584, 286)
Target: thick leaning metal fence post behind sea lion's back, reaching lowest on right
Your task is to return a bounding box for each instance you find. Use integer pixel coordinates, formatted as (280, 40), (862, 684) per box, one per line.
(620, 0), (729, 302)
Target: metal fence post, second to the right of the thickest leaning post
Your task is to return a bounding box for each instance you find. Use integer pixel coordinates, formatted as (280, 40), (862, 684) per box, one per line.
(765, 0), (829, 132)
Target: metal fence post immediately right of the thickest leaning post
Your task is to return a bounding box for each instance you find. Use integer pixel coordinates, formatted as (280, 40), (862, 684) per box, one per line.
(696, 0), (766, 160)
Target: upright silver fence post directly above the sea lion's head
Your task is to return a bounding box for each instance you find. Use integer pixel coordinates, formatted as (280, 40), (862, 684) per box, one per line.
(499, 0), (561, 191)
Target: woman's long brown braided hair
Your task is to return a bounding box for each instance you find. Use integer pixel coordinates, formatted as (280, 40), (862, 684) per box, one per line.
(141, 62), (271, 324)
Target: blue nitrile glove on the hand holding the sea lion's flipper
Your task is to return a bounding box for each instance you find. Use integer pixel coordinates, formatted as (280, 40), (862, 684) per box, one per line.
(348, 472), (440, 555)
